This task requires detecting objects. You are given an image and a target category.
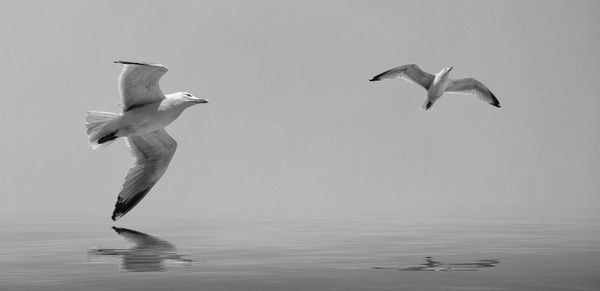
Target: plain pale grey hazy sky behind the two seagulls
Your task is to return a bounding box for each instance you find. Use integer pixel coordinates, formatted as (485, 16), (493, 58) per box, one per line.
(0, 1), (600, 222)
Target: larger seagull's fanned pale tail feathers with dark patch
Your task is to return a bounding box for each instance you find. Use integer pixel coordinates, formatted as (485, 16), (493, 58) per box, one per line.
(85, 111), (119, 150)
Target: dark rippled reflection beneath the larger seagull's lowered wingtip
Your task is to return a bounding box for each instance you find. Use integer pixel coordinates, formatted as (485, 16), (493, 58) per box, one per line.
(89, 226), (193, 272)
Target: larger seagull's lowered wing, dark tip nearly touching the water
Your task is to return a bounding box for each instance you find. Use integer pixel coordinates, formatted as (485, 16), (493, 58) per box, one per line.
(112, 129), (177, 220)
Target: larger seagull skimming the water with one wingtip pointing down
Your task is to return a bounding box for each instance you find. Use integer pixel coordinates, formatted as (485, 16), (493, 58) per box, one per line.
(85, 61), (208, 220)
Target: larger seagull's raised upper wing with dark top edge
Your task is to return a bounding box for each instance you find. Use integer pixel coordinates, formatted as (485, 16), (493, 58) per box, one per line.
(115, 61), (167, 112)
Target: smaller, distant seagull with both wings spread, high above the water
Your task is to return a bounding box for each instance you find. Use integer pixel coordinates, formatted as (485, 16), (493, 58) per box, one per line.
(369, 64), (500, 111)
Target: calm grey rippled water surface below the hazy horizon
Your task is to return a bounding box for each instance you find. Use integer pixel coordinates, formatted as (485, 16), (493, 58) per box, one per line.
(0, 213), (600, 290)
